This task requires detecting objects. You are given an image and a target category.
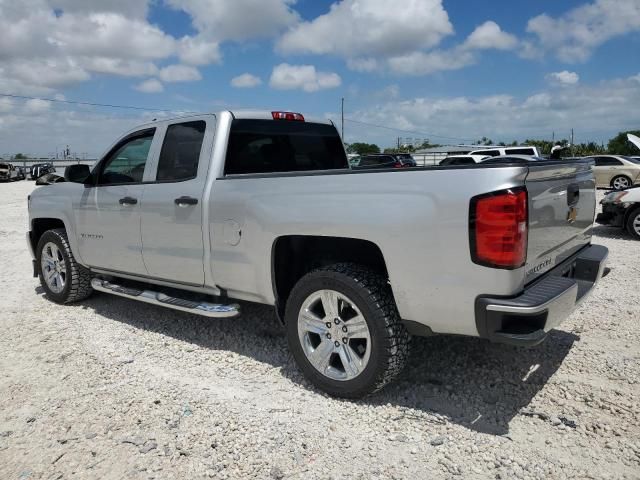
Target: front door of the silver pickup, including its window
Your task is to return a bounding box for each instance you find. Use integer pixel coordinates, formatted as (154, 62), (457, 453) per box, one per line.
(74, 128), (156, 275)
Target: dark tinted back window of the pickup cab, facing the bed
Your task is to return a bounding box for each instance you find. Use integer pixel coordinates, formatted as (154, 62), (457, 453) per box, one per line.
(224, 119), (349, 175)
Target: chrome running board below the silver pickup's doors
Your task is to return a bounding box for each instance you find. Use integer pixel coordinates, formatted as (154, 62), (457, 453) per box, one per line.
(91, 278), (240, 318)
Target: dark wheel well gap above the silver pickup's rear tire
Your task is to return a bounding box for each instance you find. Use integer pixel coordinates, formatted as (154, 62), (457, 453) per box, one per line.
(271, 235), (389, 323)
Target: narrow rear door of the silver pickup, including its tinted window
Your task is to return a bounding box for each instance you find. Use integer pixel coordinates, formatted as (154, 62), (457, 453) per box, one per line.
(141, 115), (215, 285)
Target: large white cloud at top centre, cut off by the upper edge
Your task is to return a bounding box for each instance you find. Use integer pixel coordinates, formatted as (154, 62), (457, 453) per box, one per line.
(277, 0), (453, 59)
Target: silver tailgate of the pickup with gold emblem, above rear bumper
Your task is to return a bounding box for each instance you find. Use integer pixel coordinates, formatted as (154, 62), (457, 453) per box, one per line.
(525, 160), (596, 283)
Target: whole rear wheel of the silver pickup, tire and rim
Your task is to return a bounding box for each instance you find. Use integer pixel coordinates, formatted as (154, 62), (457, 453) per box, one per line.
(285, 263), (410, 398)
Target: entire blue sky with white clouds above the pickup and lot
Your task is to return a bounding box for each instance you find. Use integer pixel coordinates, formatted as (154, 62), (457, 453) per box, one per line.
(0, 0), (640, 155)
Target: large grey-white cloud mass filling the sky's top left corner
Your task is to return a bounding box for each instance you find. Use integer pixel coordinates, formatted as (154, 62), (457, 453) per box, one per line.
(0, 0), (220, 94)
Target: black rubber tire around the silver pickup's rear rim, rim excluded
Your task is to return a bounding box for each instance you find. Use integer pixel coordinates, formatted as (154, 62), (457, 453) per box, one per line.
(285, 263), (410, 399)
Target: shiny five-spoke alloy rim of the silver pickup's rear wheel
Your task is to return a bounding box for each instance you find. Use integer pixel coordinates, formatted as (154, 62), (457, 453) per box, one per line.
(298, 290), (371, 381)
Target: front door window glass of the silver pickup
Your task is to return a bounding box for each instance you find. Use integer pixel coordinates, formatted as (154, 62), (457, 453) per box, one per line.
(97, 129), (155, 185)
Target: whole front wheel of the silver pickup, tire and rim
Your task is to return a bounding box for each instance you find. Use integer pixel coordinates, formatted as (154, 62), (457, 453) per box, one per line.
(36, 228), (93, 303)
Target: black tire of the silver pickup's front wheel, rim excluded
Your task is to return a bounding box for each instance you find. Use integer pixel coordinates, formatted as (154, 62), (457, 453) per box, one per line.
(36, 228), (93, 303)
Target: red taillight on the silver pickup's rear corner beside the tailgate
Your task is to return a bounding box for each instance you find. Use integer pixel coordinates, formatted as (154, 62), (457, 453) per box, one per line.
(469, 188), (528, 269)
